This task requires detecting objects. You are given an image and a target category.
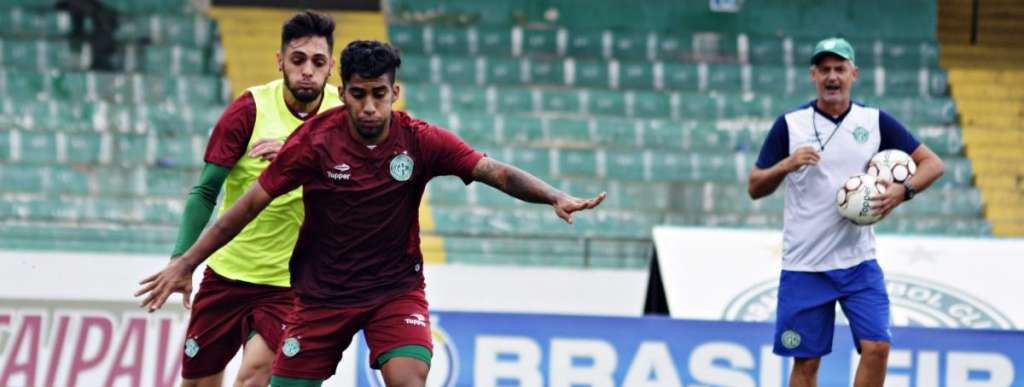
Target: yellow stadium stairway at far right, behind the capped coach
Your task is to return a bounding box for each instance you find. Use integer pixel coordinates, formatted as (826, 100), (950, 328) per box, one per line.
(938, 0), (1024, 237)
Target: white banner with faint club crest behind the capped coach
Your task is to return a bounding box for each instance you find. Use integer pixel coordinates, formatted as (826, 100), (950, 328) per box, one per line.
(654, 227), (1024, 330)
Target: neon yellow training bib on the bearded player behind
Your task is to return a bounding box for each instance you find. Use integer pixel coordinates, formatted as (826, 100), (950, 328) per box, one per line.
(209, 80), (341, 288)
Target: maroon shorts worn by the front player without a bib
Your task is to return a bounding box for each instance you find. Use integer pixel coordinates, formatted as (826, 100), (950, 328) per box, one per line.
(273, 289), (433, 380)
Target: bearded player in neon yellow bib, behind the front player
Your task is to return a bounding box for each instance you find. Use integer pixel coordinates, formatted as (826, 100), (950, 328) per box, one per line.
(161, 11), (341, 387)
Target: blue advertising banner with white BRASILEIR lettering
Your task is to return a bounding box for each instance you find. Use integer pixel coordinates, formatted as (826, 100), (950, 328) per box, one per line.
(356, 312), (1024, 387)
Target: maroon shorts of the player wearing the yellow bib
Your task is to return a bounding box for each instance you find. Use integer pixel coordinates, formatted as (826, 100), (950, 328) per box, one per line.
(181, 267), (295, 379)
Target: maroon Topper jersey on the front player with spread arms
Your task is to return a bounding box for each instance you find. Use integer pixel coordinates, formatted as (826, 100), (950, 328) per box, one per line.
(259, 106), (483, 307)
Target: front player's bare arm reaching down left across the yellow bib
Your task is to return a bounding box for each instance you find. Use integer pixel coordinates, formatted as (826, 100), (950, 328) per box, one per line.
(135, 184), (273, 312)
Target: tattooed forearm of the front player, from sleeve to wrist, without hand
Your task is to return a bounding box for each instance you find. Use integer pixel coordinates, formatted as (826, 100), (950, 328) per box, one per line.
(473, 158), (565, 204)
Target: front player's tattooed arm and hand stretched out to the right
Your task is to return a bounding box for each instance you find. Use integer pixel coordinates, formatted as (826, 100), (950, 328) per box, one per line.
(473, 158), (607, 224)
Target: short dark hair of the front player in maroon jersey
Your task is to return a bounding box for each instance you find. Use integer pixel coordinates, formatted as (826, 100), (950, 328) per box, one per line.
(341, 40), (401, 83)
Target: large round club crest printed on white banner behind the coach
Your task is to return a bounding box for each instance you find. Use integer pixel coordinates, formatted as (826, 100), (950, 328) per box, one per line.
(722, 274), (1016, 330)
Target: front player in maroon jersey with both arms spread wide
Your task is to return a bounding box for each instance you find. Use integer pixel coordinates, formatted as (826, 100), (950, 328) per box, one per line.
(138, 41), (605, 386)
